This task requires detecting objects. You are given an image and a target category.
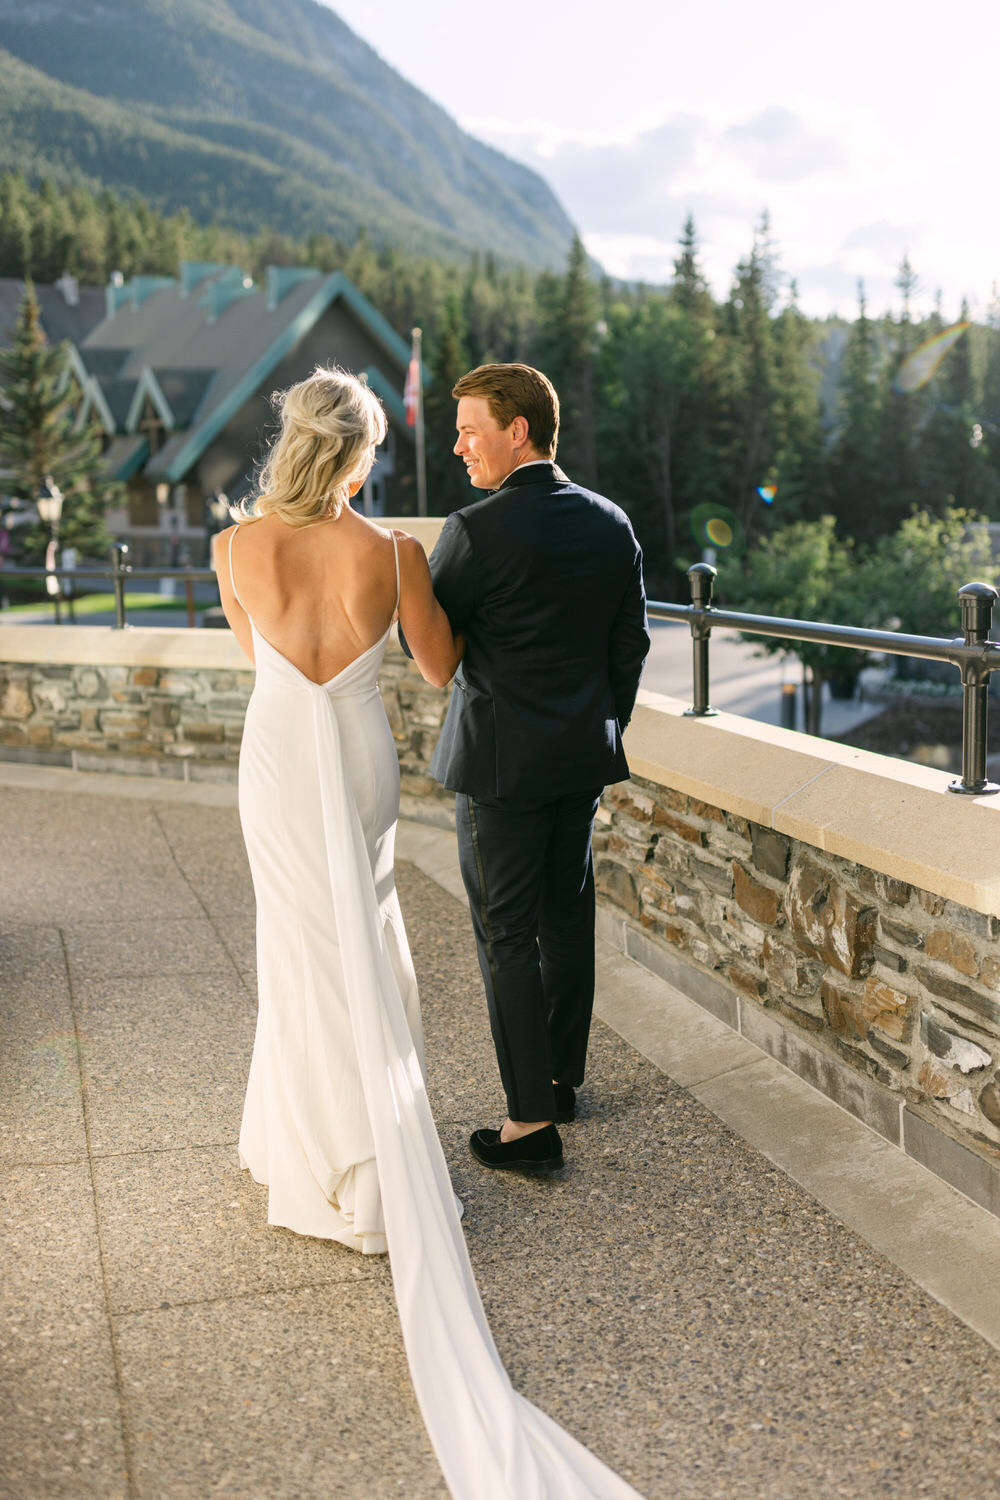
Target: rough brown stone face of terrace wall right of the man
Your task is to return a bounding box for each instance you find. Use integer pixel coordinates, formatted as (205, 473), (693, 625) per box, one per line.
(595, 777), (1000, 1161)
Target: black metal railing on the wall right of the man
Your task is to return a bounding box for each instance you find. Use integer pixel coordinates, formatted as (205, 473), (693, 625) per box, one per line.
(648, 563), (1000, 797)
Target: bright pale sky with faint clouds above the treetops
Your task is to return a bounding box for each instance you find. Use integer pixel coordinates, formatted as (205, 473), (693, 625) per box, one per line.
(328, 0), (1000, 321)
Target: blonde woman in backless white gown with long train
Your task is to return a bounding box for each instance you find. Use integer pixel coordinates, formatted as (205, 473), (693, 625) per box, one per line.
(214, 368), (636, 1500)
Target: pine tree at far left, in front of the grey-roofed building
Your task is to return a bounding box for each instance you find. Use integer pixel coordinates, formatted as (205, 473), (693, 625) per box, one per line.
(0, 282), (121, 561)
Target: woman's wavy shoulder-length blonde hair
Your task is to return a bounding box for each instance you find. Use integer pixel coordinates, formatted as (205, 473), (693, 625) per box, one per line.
(242, 365), (387, 527)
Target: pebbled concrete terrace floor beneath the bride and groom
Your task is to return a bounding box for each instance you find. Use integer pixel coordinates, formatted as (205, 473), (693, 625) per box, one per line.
(0, 767), (1000, 1500)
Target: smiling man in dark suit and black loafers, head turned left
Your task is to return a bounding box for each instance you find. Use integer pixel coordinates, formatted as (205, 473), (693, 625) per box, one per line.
(407, 365), (649, 1170)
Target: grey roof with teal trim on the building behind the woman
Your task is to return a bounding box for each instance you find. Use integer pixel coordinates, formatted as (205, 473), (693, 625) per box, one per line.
(73, 263), (419, 482)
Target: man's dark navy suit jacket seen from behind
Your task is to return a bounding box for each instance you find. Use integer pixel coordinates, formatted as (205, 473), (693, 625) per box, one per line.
(404, 464), (649, 800)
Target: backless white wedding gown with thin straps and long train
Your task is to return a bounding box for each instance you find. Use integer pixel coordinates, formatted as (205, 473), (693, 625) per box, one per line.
(229, 531), (639, 1500)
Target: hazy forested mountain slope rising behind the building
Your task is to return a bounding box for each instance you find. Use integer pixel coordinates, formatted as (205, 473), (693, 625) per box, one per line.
(0, 0), (573, 266)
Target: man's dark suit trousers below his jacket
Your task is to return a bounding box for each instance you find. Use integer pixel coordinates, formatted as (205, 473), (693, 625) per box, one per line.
(456, 788), (601, 1121)
